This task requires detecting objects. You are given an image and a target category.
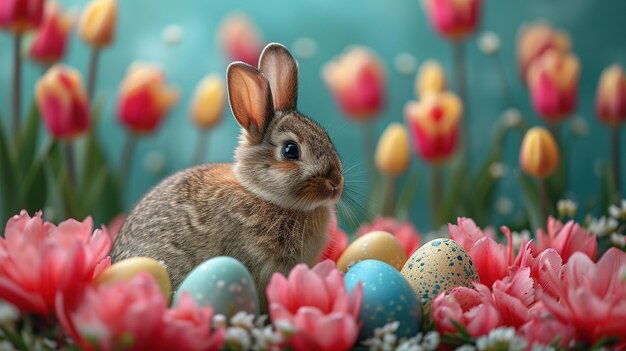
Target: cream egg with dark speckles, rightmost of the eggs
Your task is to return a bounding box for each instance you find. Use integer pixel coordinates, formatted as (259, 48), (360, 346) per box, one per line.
(401, 238), (479, 311)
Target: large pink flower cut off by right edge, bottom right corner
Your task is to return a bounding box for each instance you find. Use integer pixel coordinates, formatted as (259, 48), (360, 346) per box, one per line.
(541, 248), (626, 347)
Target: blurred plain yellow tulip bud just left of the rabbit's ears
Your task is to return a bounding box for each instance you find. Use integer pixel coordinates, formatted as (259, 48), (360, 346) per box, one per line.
(189, 74), (226, 129)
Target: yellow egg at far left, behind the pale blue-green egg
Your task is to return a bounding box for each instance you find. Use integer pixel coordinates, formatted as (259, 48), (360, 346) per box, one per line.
(94, 257), (172, 301)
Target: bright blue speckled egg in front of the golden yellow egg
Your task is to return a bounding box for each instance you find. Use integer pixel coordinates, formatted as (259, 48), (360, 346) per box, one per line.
(344, 260), (421, 340)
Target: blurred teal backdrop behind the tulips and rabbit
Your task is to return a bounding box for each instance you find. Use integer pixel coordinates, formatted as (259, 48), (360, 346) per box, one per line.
(0, 0), (626, 230)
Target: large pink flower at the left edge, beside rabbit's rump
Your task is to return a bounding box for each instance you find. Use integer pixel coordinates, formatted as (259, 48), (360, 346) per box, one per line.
(0, 211), (111, 315)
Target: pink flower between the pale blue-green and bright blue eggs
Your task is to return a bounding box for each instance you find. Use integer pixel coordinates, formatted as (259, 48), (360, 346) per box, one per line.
(266, 260), (363, 351)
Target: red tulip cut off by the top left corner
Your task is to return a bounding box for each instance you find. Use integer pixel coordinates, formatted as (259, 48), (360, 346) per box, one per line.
(0, 0), (44, 34)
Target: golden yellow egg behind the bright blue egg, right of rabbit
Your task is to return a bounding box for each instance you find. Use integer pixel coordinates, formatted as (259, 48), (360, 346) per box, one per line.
(337, 230), (406, 272)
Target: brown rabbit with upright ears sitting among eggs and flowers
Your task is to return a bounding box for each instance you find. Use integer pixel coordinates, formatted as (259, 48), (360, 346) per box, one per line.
(111, 43), (343, 310)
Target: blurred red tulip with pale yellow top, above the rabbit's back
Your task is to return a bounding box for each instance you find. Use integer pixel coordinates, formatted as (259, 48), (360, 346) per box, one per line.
(117, 63), (178, 133)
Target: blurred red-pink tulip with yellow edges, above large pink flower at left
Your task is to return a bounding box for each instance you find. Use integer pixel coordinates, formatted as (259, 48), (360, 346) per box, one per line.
(35, 64), (89, 140)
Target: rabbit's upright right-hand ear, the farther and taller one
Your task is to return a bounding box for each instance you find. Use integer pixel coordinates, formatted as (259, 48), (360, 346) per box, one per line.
(259, 43), (298, 110)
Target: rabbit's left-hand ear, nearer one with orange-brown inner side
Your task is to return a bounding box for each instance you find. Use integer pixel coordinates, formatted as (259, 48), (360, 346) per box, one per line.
(226, 62), (274, 144)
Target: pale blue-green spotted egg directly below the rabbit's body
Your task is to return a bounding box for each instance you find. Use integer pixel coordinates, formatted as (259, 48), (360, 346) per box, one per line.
(174, 256), (259, 318)
